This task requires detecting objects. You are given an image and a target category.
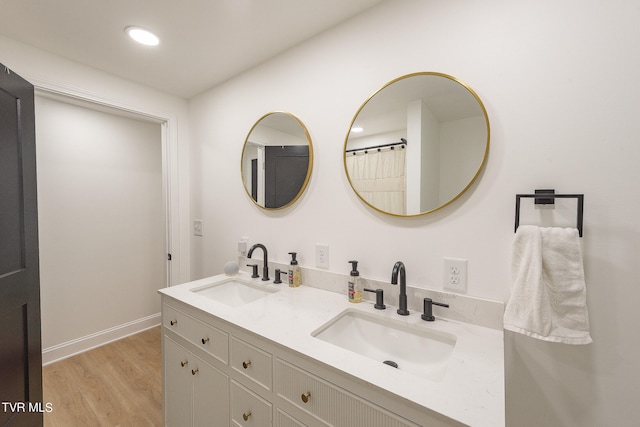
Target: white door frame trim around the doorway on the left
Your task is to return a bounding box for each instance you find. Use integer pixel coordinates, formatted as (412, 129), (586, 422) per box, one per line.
(29, 79), (182, 287)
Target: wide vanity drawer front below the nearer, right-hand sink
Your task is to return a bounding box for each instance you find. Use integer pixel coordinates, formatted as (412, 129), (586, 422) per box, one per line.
(275, 358), (418, 427)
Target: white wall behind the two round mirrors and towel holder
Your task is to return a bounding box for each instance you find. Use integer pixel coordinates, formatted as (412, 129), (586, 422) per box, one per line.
(190, 0), (640, 426)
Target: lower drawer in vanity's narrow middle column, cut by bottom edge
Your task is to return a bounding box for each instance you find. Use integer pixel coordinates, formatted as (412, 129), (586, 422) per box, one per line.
(231, 381), (271, 427)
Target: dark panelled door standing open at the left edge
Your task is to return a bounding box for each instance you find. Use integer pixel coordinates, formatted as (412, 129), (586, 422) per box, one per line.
(0, 64), (44, 426)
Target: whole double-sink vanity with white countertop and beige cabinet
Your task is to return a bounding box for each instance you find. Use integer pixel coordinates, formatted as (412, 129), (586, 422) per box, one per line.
(160, 272), (504, 427)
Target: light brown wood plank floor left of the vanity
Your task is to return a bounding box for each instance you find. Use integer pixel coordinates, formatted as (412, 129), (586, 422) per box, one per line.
(43, 326), (162, 427)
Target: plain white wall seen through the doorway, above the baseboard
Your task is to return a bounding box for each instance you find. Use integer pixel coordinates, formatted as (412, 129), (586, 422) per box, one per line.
(35, 96), (166, 353)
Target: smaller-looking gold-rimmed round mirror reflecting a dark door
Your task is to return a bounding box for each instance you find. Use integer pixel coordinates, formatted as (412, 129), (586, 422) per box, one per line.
(240, 112), (313, 209)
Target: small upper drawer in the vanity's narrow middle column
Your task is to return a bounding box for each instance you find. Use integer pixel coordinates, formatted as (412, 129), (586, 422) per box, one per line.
(231, 336), (273, 391)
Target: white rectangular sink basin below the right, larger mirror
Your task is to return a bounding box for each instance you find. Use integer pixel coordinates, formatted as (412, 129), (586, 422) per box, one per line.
(311, 309), (456, 381)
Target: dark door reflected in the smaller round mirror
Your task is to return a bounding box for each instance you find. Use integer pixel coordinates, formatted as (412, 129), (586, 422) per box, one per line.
(264, 145), (309, 208)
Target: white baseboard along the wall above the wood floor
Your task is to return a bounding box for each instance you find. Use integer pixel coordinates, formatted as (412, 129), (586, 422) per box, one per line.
(42, 313), (161, 366)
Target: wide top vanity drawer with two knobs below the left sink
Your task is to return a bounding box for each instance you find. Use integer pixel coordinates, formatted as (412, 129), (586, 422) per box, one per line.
(162, 305), (229, 364)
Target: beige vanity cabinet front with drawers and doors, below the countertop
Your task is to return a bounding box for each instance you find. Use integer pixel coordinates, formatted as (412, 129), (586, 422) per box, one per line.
(162, 296), (456, 427)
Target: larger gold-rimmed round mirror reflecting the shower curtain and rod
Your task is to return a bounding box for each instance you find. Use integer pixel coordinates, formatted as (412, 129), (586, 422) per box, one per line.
(344, 72), (489, 216)
